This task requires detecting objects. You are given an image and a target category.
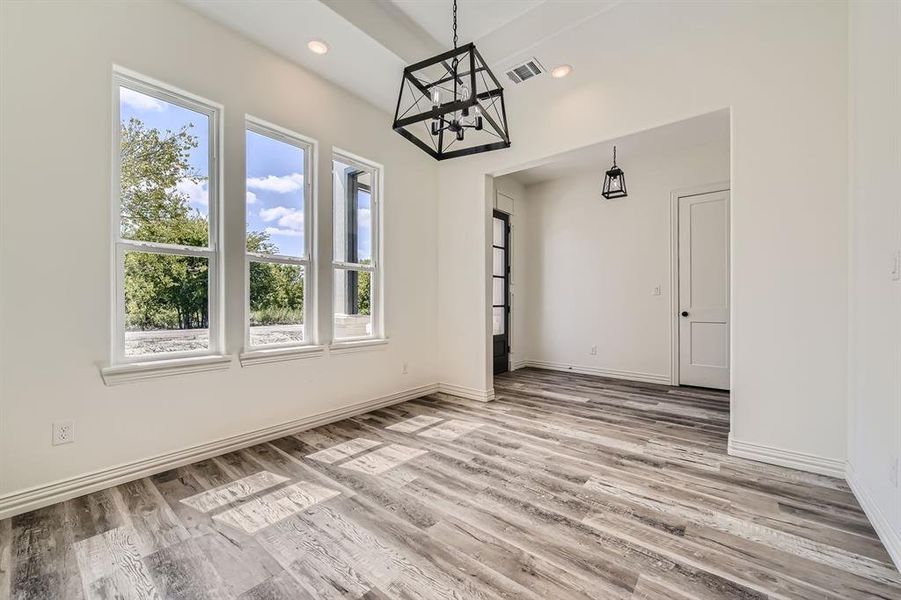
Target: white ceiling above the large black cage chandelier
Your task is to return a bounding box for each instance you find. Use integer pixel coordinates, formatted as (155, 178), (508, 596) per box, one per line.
(181, 0), (622, 113)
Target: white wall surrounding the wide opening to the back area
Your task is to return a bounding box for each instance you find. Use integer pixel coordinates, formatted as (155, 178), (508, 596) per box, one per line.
(439, 2), (848, 465)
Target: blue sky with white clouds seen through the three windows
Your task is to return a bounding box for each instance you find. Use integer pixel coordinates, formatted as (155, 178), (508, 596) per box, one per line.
(119, 88), (372, 260)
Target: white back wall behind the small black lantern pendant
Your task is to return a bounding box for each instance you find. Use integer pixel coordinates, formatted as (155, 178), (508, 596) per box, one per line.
(514, 138), (729, 383)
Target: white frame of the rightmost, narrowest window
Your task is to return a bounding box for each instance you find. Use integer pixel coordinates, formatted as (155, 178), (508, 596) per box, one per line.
(331, 147), (387, 347)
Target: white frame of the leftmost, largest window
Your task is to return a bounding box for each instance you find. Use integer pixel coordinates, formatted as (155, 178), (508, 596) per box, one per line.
(110, 65), (225, 366)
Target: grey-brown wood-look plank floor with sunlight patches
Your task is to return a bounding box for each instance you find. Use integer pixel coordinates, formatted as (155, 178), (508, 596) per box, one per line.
(0, 369), (901, 600)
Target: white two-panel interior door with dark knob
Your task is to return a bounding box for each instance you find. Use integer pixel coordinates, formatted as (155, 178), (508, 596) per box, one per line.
(679, 190), (729, 390)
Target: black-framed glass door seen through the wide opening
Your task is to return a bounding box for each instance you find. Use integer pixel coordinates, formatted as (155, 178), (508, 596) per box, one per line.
(491, 211), (510, 374)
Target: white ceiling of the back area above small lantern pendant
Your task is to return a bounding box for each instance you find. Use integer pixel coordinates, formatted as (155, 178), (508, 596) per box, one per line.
(507, 109), (729, 185)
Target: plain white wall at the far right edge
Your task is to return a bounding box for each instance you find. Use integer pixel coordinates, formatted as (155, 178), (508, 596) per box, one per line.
(848, 2), (901, 567)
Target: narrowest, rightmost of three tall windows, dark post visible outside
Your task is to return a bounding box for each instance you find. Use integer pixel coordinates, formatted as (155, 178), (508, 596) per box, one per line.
(332, 154), (382, 341)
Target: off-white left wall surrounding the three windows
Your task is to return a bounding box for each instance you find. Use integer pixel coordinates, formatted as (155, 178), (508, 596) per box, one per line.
(0, 2), (437, 504)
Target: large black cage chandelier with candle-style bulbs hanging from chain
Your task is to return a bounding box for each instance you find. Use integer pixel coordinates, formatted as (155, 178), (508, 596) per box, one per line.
(394, 0), (510, 160)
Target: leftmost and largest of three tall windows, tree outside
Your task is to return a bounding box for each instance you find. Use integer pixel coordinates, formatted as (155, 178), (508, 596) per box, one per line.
(113, 74), (221, 363)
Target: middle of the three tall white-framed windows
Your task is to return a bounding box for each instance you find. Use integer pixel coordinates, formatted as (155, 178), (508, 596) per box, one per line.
(245, 119), (314, 349)
